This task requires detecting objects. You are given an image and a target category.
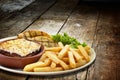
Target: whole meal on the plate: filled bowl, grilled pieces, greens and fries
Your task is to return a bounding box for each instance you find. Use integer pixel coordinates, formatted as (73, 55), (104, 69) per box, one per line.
(0, 30), (91, 72)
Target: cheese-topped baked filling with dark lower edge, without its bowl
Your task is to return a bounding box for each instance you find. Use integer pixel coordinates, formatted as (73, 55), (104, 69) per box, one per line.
(0, 38), (41, 57)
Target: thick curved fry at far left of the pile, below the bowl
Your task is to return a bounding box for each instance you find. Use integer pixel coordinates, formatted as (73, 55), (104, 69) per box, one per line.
(23, 61), (47, 72)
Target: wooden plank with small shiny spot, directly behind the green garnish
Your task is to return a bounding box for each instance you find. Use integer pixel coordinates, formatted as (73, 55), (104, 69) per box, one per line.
(60, 5), (98, 80)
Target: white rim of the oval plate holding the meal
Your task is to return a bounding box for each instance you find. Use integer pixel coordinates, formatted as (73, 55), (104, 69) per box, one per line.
(0, 36), (96, 76)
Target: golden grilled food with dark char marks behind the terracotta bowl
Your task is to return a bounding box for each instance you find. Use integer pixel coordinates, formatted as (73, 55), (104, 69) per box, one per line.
(18, 30), (58, 47)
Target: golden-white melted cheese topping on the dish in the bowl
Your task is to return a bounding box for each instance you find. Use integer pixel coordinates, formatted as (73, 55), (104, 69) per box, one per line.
(0, 39), (41, 56)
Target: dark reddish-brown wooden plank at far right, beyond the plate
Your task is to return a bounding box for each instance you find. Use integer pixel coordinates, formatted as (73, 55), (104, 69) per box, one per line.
(87, 8), (120, 80)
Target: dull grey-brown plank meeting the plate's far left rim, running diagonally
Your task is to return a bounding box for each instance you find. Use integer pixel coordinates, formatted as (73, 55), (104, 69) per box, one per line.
(0, 0), (55, 38)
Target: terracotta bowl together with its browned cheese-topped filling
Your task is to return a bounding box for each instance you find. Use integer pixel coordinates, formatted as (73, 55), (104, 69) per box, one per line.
(0, 38), (44, 68)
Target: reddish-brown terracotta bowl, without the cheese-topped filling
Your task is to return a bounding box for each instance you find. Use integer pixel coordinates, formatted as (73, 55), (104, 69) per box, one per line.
(0, 37), (44, 69)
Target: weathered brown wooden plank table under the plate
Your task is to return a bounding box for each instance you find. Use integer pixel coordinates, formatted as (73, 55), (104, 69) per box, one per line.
(0, 0), (120, 80)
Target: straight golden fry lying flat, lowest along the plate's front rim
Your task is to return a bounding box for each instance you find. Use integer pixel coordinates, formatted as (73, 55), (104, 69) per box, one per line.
(34, 67), (63, 72)
